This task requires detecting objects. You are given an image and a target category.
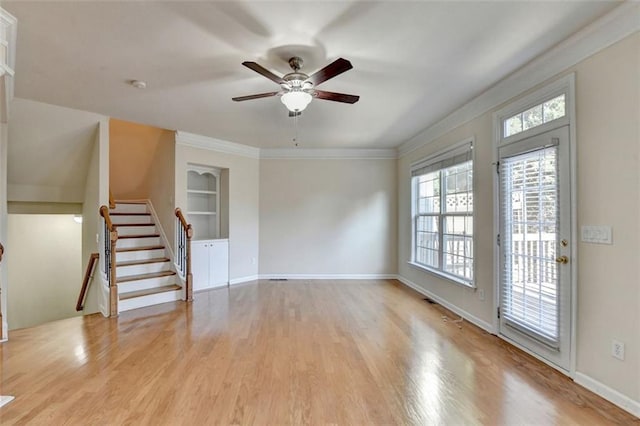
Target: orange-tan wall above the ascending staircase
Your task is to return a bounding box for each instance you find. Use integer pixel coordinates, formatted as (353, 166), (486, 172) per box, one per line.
(109, 119), (175, 248)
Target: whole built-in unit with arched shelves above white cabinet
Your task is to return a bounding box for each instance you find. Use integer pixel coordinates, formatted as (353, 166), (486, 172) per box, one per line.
(187, 165), (229, 291)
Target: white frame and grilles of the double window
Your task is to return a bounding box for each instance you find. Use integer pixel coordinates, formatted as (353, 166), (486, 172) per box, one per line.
(408, 138), (476, 288)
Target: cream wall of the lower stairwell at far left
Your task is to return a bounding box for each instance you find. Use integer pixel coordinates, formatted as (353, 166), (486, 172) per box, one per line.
(3, 214), (82, 330)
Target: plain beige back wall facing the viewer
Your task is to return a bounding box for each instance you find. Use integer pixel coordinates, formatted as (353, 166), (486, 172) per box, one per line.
(260, 160), (397, 275)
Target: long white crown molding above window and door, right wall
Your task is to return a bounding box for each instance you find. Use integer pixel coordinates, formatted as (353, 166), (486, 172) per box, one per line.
(398, 2), (640, 157)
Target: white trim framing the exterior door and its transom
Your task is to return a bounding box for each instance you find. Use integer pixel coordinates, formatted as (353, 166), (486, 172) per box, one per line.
(492, 73), (578, 378)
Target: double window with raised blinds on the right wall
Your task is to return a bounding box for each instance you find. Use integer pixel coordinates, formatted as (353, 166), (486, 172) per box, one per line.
(411, 142), (474, 286)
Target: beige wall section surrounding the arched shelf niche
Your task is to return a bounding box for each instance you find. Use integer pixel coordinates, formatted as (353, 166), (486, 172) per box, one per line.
(175, 144), (260, 282)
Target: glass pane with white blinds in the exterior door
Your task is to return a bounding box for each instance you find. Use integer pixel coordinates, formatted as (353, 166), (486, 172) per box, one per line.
(500, 146), (559, 346)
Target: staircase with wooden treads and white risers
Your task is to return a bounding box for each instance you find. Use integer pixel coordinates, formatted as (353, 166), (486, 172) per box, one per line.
(109, 201), (183, 312)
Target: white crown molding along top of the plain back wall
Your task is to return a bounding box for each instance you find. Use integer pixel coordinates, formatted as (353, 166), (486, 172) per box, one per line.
(260, 148), (398, 160)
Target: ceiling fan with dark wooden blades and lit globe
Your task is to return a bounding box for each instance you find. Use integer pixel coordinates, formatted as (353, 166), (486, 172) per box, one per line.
(232, 56), (360, 117)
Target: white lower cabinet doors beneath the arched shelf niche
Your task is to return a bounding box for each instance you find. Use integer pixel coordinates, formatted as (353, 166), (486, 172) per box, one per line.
(191, 239), (229, 291)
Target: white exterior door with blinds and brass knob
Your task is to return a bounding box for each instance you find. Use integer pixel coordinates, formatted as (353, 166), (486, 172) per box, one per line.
(498, 126), (572, 371)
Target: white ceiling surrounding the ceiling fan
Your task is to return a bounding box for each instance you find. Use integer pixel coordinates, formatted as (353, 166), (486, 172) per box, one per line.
(2, 1), (619, 148)
